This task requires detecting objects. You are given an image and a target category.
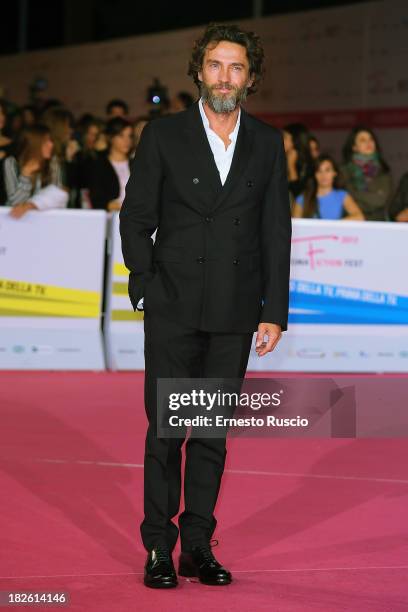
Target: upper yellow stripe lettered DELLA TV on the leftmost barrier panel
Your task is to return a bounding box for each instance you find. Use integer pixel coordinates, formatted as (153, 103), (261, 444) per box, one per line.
(0, 278), (100, 307)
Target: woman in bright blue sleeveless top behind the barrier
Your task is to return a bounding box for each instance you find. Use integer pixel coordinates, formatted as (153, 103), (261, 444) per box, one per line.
(293, 155), (364, 220)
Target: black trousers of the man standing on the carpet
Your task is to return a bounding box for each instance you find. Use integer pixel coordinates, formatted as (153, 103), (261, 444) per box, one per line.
(140, 312), (253, 552)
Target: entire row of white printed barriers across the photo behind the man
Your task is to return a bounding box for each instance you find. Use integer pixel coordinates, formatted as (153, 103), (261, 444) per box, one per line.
(0, 209), (408, 372)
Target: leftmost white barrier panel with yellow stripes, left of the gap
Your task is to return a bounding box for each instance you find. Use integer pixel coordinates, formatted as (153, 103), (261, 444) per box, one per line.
(0, 208), (106, 370)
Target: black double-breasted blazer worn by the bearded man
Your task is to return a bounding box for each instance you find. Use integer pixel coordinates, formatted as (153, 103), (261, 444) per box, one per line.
(120, 102), (291, 333)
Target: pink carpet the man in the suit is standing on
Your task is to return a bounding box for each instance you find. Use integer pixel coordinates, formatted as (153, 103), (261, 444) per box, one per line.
(0, 372), (408, 612)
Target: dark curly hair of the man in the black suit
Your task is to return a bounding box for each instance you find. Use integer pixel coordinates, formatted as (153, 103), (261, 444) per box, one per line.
(187, 23), (265, 95)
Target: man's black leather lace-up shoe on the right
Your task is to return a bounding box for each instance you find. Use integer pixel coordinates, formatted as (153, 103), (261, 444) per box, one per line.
(178, 540), (232, 586)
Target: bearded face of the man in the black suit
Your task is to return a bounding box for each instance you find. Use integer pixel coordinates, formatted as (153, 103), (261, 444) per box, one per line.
(198, 40), (253, 113)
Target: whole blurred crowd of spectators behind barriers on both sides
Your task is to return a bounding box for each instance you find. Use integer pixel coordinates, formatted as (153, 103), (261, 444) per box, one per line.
(0, 92), (408, 222)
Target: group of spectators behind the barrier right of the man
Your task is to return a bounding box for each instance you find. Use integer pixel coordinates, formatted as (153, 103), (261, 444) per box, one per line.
(283, 123), (408, 221)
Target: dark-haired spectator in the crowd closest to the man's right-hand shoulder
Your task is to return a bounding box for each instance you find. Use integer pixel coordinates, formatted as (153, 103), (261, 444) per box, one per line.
(283, 123), (313, 199)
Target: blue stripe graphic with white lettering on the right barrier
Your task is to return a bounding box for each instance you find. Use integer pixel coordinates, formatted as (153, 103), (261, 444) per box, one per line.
(289, 280), (408, 325)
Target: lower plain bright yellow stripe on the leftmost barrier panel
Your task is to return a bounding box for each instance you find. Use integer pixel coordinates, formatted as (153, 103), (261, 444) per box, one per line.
(0, 297), (99, 319)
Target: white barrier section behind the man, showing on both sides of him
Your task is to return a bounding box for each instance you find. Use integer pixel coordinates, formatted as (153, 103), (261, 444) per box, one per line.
(105, 215), (408, 372)
